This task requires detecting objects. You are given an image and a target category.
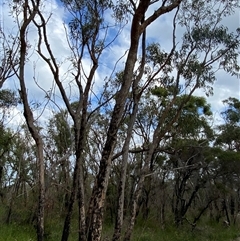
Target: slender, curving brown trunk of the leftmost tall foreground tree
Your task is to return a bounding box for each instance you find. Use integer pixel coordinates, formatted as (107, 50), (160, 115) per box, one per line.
(16, 0), (45, 241)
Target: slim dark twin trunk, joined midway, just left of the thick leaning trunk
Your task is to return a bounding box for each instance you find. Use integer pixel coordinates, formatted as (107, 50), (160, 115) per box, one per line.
(61, 51), (98, 241)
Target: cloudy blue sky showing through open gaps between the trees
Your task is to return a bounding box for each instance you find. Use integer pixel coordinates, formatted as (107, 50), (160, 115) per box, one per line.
(0, 0), (240, 127)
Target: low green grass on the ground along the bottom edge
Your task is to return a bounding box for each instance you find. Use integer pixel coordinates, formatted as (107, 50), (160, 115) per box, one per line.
(0, 220), (240, 241)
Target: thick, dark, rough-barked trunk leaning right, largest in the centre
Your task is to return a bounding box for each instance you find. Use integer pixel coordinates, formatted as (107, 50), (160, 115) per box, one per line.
(87, 1), (149, 241)
